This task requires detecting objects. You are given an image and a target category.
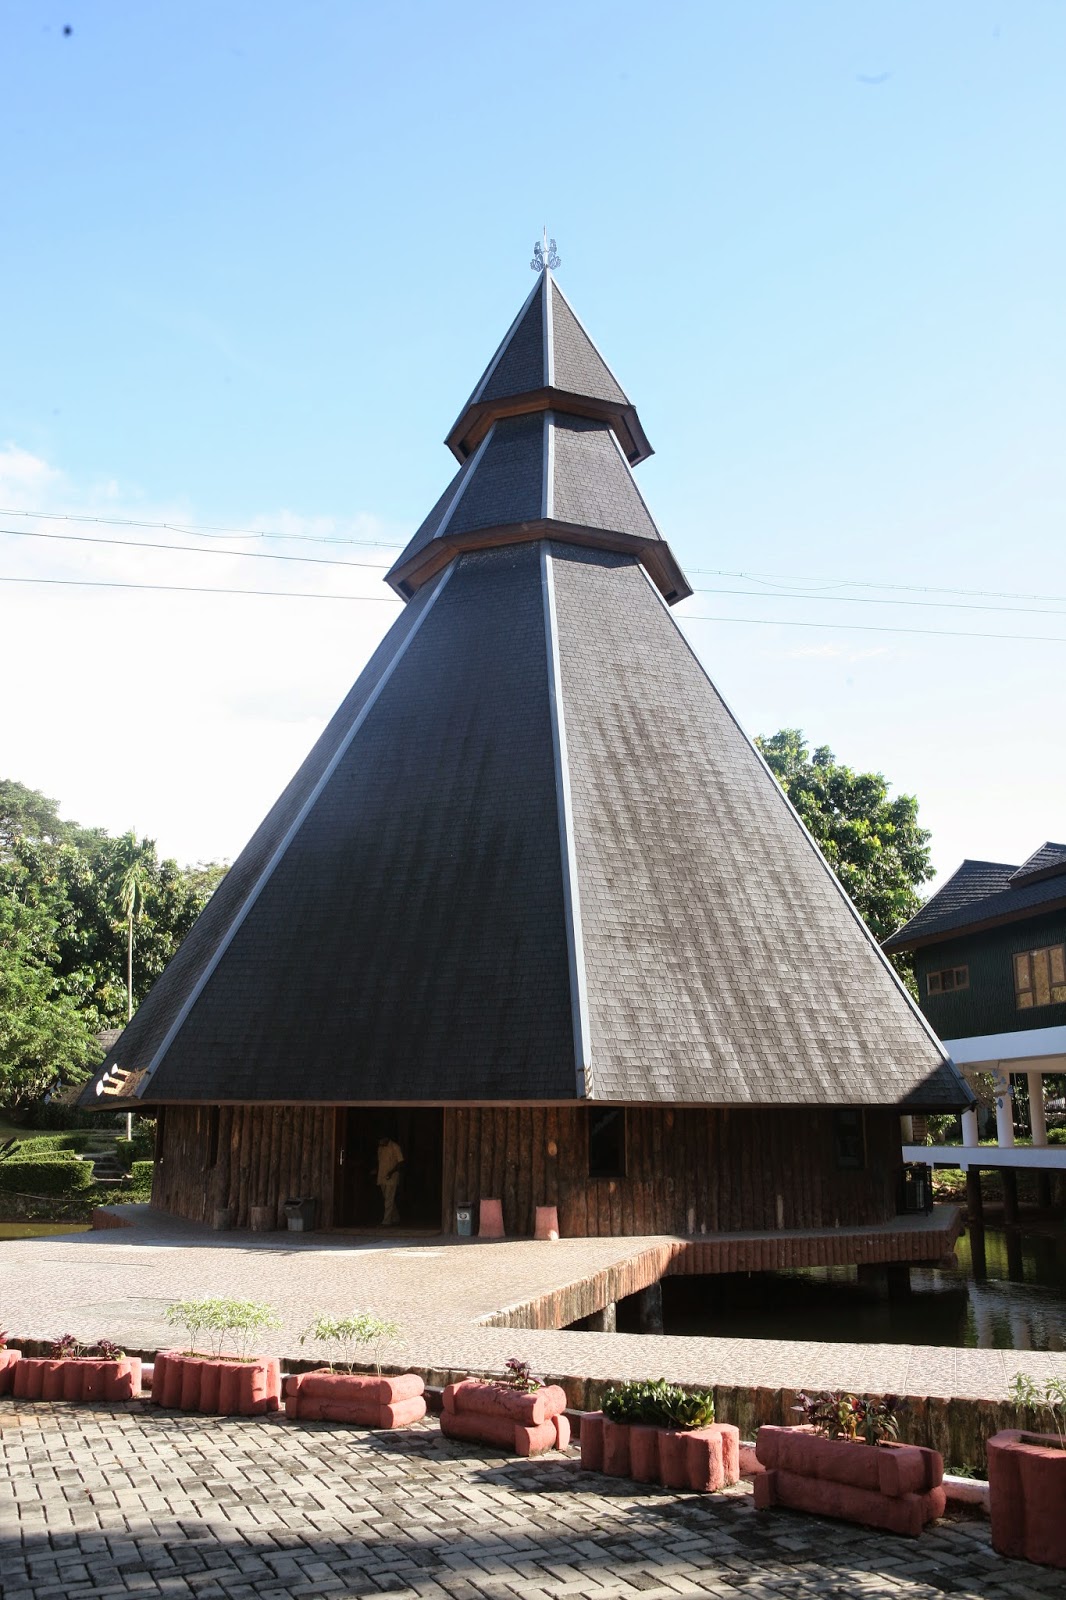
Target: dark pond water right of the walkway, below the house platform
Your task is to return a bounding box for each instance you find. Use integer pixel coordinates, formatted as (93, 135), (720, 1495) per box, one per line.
(643, 1222), (1066, 1350)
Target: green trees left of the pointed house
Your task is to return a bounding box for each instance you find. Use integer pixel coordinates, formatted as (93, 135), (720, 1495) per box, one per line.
(0, 778), (226, 1109)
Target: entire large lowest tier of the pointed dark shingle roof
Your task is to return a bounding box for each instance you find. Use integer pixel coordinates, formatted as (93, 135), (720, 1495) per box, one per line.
(83, 542), (967, 1107)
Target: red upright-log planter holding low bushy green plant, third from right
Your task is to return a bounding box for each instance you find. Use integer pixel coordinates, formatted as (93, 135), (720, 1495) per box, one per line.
(581, 1411), (739, 1494)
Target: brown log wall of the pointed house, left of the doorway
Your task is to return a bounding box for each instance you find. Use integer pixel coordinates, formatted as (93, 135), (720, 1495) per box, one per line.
(152, 1106), (335, 1227)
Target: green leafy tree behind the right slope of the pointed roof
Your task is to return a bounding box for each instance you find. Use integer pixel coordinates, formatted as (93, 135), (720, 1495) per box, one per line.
(755, 728), (933, 953)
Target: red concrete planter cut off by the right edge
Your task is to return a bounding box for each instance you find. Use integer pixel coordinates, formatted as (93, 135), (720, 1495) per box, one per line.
(988, 1429), (1066, 1566)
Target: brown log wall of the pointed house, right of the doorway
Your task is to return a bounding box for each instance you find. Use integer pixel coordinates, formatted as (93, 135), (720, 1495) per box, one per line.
(443, 1106), (901, 1237)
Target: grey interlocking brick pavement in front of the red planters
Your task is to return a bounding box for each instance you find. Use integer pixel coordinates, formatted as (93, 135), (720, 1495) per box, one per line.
(0, 1400), (1063, 1600)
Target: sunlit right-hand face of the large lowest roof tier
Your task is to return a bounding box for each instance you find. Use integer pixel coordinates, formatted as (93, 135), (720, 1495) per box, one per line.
(552, 547), (968, 1106)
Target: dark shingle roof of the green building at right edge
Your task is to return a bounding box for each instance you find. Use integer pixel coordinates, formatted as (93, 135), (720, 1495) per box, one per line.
(884, 845), (1066, 950)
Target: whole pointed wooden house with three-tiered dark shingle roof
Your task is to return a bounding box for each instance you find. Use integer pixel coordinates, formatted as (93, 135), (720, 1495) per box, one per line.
(85, 270), (970, 1234)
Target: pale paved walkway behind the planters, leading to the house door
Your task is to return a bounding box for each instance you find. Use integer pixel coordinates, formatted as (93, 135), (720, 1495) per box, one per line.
(0, 1208), (1066, 1400)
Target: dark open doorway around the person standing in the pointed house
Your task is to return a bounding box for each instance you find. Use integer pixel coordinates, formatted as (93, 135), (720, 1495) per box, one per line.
(333, 1106), (443, 1230)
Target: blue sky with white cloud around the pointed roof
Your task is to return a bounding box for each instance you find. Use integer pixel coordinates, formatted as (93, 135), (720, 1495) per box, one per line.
(0, 0), (1066, 872)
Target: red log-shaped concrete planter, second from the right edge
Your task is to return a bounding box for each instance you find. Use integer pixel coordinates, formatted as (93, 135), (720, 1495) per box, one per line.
(754, 1424), (948, 1538)
